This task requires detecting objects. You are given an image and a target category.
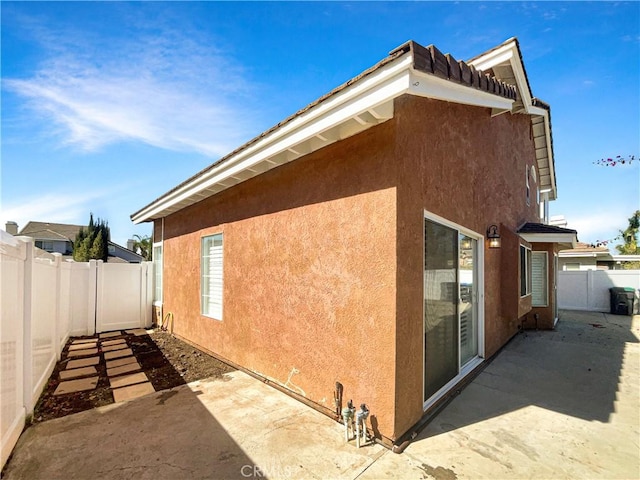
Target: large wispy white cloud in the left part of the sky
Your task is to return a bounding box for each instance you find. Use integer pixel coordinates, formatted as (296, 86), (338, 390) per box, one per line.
(3, 15), (262, 157)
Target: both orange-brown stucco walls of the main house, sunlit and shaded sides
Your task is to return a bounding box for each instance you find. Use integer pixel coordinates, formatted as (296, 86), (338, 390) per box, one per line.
(154, 96), (539, 440)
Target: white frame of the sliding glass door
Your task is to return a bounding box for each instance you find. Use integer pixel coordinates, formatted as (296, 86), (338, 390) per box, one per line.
(422, 210), (485, 410)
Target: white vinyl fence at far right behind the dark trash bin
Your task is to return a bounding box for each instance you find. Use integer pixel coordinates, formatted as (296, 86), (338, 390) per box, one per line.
(558, 270), (640, 313)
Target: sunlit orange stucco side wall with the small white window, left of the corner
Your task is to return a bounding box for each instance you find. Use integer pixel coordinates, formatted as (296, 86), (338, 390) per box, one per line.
(159, 122), (396, 436)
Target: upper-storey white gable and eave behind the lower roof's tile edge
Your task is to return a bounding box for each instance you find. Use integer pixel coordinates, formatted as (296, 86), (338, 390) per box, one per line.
(468, 38), (557, 200)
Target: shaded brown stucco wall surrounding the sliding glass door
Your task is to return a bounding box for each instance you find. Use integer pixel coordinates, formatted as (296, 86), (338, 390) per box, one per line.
(394, 96), (539, 436)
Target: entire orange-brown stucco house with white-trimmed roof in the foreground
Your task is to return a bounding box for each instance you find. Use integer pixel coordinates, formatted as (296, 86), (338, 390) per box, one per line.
(131, 39), (577, 444)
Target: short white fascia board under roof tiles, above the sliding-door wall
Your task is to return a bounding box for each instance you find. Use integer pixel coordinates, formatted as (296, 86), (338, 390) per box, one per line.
(409, 70), (514, 110)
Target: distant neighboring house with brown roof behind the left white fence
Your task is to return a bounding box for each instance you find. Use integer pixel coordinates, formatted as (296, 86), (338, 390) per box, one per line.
(5, 222), (144, 263)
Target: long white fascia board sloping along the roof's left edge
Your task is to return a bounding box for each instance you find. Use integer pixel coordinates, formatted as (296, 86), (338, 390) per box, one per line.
(132, 55), (413, 224)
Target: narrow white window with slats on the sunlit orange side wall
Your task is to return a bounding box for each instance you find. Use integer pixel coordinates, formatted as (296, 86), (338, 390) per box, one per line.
(200, 233), (223, 320)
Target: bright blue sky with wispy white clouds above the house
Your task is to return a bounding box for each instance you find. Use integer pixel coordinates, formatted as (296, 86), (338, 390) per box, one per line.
(0, 1), (640, 248)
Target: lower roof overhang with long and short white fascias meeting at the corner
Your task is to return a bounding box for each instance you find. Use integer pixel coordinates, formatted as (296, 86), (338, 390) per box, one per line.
(131, 42), (516, 223)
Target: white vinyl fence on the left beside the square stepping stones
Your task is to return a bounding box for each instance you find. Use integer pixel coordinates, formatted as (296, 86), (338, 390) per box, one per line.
(0, 234), (153, 468)
